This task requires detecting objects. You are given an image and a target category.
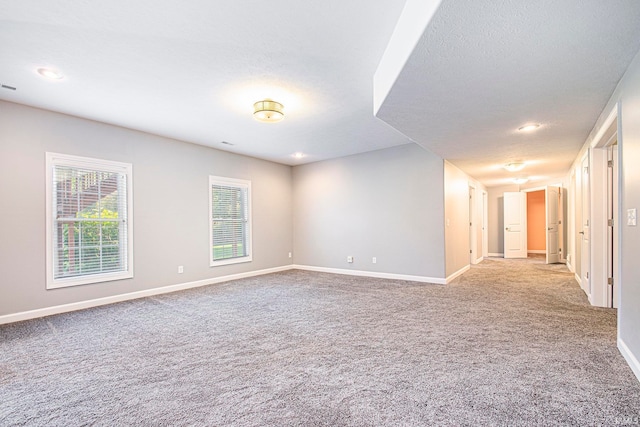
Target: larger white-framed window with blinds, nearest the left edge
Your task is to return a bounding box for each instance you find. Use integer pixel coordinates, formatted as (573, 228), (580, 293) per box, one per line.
(46, 153), (133, 289)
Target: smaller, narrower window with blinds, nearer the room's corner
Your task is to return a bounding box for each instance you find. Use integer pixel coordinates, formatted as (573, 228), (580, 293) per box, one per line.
(209, 176), (251, 267)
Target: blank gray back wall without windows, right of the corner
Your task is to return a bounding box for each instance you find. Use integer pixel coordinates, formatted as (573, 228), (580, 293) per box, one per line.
(293, 144), (445, 278)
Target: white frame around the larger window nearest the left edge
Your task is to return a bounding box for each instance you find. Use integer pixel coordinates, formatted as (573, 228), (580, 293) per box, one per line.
(46, 152), (133, 289)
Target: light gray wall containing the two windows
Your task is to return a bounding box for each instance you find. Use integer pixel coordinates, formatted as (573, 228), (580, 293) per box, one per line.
(0, 102), (293, 315)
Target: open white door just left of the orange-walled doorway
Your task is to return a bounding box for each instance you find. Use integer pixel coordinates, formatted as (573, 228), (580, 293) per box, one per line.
(504, 192), (527, 258)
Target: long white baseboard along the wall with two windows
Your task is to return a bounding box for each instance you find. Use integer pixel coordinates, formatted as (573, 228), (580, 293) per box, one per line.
(0, 265), (293, 325)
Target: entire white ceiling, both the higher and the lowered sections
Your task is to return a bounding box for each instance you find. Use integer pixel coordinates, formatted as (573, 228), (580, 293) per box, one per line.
(0, 0), (640, 185)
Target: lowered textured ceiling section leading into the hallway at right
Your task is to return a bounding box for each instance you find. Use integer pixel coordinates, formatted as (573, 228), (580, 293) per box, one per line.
(377, 0), (640, 186)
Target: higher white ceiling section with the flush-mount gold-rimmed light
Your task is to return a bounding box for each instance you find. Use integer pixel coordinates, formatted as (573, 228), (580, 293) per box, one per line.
(0, 0), (409, 164)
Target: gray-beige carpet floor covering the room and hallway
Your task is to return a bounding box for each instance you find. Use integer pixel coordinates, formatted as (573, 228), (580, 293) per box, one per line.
(0, 259), (640, 426)
